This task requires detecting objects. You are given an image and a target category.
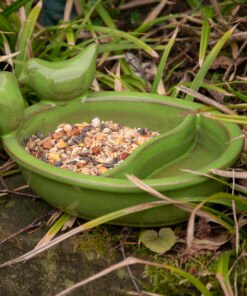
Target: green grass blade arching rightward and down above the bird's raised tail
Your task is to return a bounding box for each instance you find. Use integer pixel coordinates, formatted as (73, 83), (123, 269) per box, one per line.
(88, 26), (159, 58)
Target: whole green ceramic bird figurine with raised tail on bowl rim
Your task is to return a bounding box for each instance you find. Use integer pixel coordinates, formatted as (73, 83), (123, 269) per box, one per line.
(19, 44), (97, 101)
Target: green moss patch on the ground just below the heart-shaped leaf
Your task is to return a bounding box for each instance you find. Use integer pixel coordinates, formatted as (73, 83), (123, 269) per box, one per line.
(139, 252), (222, 296)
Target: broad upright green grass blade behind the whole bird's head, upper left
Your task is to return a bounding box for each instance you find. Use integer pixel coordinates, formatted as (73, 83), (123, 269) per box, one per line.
(15, 1), (42, 77)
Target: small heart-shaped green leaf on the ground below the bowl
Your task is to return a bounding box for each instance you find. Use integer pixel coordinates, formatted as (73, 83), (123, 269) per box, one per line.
(139, 228), (176, 254)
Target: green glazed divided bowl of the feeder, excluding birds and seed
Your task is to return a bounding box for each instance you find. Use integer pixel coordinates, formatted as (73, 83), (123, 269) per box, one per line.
(0, 92), (243, 226)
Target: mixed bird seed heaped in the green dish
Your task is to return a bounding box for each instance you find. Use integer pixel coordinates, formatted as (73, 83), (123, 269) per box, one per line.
(24, 117), (159, 176)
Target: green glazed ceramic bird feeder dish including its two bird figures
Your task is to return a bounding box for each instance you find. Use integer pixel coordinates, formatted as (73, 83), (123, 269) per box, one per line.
(0, 45), (243, 227)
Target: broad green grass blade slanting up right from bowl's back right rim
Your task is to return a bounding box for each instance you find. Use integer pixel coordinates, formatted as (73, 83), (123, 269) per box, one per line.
(185, 27), (235, 101)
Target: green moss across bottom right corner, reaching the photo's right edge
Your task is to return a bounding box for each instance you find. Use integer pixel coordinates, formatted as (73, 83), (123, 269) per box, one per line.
(138, 247), (247, 296)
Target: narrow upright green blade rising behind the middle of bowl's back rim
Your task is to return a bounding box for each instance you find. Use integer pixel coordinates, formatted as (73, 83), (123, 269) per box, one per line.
(151, 28), (178, 93)
